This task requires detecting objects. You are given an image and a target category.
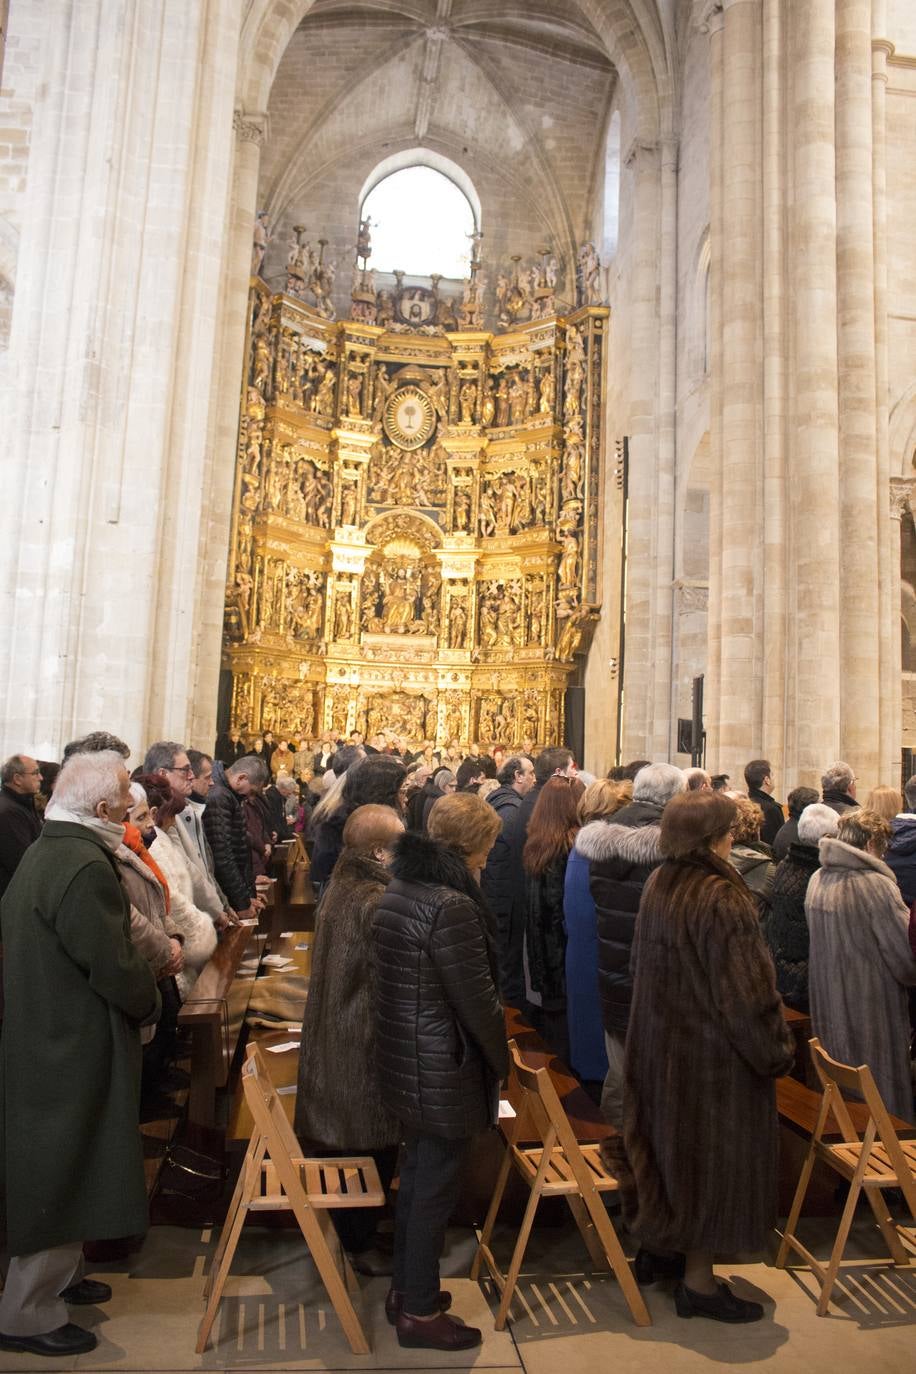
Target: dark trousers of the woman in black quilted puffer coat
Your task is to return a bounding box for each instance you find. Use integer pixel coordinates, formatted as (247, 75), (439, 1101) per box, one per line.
(391, 1131), (471, 1316)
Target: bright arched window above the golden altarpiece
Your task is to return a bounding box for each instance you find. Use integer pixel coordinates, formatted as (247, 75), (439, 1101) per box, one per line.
(360, 150), (481, 279)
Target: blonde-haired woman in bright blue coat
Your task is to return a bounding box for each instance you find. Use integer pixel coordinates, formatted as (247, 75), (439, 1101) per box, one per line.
(563, 778), (633, 1083)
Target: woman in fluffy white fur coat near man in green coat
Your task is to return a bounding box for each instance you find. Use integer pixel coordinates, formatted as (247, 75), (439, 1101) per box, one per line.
(132, 774), (217, 1002)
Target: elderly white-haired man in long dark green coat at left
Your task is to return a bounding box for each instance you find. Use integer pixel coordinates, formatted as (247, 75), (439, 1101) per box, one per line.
(0, 753), (159, 1355)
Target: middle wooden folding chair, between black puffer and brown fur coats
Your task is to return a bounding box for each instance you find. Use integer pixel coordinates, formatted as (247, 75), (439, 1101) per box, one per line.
(471, 1040), (651, 1331)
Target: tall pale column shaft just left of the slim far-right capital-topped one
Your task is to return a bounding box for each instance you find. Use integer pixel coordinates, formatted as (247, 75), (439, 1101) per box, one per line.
(836, 0), (890, 793)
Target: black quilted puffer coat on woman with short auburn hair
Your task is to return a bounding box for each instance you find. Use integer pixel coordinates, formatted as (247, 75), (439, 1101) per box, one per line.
(372, 833), (508, 1139)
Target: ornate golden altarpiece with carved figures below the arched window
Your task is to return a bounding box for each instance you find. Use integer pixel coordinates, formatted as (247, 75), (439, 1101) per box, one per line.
(224, 259), (608, 745)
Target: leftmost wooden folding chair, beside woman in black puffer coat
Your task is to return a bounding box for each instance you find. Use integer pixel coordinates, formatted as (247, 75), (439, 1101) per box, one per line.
(196, 1044), (385, 1355)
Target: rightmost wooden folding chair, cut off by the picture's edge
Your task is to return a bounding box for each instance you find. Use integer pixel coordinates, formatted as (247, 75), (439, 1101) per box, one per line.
(776, 1037), (916, 1316)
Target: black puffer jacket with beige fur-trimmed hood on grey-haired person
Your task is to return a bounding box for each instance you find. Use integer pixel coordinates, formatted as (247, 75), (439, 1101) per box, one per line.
(575, 801), (662, 1035)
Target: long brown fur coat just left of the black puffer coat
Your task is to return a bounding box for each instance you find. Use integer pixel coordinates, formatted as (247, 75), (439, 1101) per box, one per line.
(294, 849), (401, 1150)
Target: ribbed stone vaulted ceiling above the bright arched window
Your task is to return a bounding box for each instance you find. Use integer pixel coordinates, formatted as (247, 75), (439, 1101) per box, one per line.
(261, 0), (615, 255)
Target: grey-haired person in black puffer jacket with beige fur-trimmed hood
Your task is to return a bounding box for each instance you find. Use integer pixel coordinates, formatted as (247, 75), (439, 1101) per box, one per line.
(575, 764), (685, 1129)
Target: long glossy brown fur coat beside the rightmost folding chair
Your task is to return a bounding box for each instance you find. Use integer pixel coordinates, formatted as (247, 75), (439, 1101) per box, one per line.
(615, 853), (792, 1252)
